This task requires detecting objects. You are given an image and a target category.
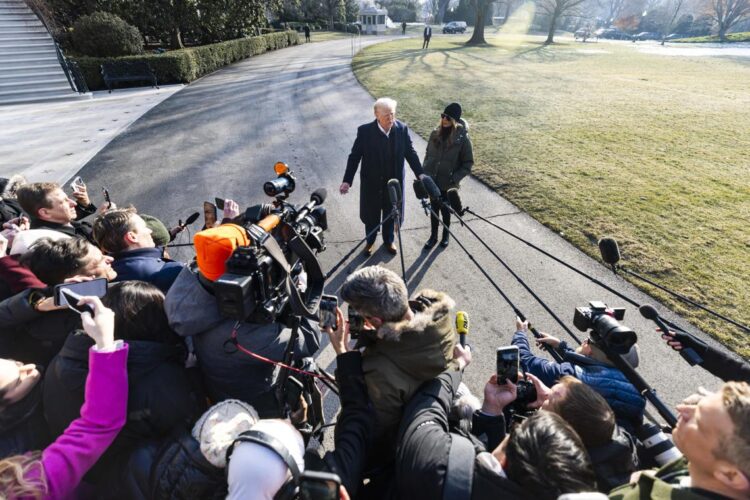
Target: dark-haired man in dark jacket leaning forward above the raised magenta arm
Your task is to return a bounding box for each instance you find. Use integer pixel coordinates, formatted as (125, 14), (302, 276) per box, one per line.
(0, 238), (117, 365)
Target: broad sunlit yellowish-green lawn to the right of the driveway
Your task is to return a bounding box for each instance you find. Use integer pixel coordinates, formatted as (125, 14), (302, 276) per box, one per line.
(353, 36), (750, 357)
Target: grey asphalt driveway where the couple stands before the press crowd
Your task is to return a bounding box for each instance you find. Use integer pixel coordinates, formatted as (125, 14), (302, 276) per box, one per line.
(80, 38), (719, 426)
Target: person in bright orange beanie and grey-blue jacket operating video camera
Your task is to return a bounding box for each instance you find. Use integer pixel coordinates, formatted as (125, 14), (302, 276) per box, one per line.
(165, 224), (321, 418)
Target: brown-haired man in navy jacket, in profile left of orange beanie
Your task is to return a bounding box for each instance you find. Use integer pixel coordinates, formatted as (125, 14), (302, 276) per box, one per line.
(93, 207), (185, 293)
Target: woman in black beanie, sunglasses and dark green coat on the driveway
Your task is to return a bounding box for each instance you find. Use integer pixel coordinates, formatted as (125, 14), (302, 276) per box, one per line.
(422, 102), (474, 249)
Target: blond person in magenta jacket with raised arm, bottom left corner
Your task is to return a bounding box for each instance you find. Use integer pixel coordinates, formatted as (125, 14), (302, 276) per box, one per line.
(0, 297), (128, 499)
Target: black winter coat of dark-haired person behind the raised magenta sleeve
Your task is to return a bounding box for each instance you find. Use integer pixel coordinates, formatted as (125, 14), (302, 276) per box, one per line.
(44, 332), (200, 491)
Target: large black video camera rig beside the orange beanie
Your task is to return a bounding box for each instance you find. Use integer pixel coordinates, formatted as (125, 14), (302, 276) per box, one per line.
(213, 162), (328, 323)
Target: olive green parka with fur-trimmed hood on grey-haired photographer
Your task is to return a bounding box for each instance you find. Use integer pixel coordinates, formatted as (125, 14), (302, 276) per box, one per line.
(362, 290), (456, 432)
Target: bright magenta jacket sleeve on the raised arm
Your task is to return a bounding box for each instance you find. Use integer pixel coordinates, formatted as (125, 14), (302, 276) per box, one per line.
(29, 344), (128, 500)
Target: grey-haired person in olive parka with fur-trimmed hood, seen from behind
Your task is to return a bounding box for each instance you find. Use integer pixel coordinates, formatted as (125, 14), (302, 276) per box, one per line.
(341, 266), (457, 462)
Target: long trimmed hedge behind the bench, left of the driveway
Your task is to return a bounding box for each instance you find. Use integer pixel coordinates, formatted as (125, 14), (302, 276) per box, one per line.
(70, 31), (299, 90)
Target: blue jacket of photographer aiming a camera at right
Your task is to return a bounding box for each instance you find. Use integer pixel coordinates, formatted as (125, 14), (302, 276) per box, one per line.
(512, 332), (646, 433)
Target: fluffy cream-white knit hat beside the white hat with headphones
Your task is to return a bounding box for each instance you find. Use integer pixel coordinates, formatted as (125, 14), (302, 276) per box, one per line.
(192, 399), (258, 468)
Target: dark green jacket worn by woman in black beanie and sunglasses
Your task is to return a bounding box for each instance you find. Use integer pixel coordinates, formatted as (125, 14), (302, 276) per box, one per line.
(422, 120), (474, 191)
